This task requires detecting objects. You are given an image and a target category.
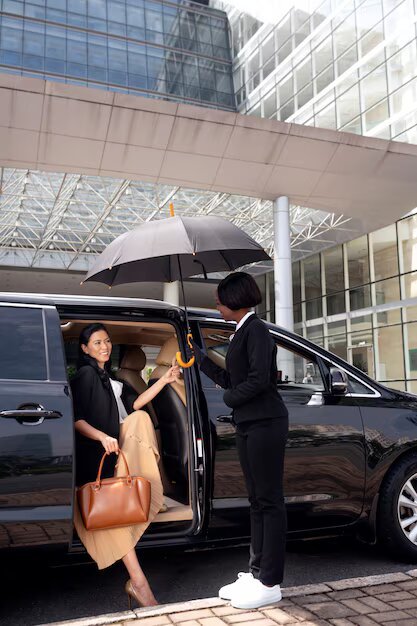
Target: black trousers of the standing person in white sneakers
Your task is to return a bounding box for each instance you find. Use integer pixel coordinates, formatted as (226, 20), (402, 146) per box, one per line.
(236, 417), (288, 586)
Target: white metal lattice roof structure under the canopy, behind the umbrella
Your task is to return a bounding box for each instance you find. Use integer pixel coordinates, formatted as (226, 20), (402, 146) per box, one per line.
(0, 168), (361, 273)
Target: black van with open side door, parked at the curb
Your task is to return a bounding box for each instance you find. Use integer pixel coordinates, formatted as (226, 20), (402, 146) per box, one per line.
(0, 293), (417, 561)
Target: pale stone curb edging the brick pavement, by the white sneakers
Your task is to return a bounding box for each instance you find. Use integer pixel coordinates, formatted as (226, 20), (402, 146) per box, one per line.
(39, 569), (417, 626)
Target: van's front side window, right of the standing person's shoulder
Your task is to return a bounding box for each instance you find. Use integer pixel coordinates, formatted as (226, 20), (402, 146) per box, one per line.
(277, 343), (324, 391)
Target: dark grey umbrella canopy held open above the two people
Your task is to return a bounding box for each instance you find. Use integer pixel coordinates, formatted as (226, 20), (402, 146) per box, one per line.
(85, 216), (270, 286)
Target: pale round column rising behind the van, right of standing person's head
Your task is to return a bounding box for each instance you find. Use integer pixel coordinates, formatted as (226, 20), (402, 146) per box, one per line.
(273, 196), (295, 382)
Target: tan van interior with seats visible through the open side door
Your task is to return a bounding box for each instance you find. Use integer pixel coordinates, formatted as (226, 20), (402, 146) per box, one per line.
(61, 319), (193, 522)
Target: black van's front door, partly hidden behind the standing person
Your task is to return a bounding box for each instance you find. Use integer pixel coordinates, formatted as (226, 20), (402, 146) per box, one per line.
(195, 322), (365, 531)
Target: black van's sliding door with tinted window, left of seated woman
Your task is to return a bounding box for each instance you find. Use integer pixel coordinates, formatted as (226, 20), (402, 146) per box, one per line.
(0, 303), (73, 548)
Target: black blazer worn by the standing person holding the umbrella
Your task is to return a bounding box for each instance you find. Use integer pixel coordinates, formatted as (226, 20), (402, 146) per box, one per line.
(200, 314), (288, 424)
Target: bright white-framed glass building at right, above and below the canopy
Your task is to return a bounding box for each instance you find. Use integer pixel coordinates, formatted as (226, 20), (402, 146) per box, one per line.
(215, 0), (417, 393)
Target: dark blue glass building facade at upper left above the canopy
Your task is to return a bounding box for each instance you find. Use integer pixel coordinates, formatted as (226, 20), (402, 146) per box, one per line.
(0, 0), (235, 110)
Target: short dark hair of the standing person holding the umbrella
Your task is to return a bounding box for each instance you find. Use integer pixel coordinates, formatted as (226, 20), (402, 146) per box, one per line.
(217, 272), (262, 311)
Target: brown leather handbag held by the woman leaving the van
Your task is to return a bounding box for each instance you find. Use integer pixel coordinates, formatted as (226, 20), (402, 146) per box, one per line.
(77, 450), (151, 530)
